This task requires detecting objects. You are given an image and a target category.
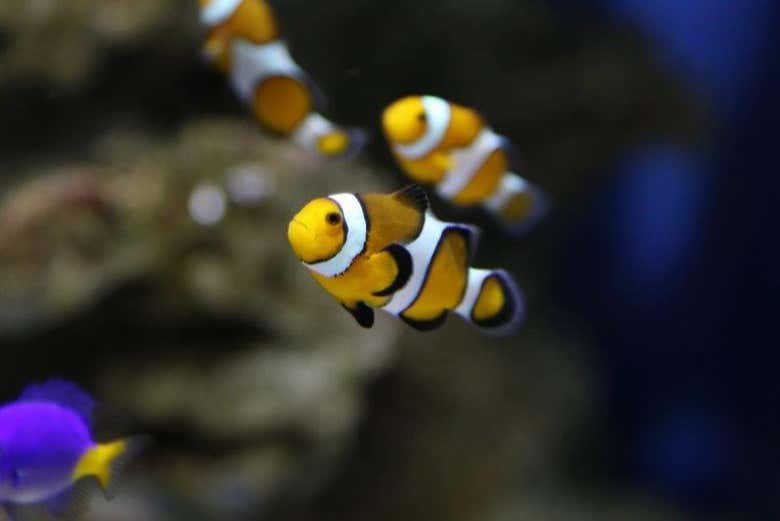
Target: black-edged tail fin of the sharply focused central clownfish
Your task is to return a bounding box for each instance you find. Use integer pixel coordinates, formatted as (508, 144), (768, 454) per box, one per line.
(455, 268), (525, 335)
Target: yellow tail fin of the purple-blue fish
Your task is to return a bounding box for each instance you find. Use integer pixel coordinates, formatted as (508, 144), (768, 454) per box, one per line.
(73, 438), (146, 498)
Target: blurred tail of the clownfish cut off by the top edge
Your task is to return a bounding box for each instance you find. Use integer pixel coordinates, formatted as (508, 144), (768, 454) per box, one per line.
(293, 112), (368, 159)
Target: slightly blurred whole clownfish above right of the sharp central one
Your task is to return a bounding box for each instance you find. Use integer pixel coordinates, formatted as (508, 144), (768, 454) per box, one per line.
(382, 96), (546, 233)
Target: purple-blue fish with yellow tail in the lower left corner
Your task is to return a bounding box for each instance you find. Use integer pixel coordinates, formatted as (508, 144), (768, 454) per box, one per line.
(0, 380), (143, 521)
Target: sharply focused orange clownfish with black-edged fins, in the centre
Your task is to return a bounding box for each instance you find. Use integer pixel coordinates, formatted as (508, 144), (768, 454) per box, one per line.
(287, 185), (524, 334)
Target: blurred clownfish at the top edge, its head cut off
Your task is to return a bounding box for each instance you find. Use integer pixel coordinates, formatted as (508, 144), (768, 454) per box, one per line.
(199, 0), (366, 158)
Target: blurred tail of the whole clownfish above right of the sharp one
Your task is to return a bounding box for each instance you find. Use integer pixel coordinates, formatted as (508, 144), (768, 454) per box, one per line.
(485, 172), (549, 235)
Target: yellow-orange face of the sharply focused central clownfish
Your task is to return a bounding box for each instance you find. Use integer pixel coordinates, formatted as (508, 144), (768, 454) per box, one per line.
(287, 197), (347, 264)
